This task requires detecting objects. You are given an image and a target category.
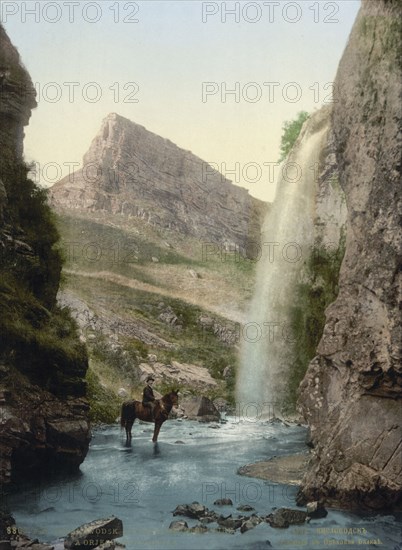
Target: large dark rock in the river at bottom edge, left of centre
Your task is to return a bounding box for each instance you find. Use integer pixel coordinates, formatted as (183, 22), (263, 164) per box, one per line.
(64, 516), (123, 550)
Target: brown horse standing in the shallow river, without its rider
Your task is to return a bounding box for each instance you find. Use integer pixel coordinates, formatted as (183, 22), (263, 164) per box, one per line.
(120, 390), (179, 443)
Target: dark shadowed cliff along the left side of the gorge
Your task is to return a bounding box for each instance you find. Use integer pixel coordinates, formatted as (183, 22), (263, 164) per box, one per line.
(0, 26), (89, 485)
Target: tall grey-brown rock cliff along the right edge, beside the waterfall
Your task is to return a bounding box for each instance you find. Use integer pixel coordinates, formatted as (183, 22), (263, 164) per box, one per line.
(299, 0), (402, 508)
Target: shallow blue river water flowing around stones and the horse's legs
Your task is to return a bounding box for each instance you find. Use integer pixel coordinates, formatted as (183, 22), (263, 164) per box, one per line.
(9, 418), (402, 550)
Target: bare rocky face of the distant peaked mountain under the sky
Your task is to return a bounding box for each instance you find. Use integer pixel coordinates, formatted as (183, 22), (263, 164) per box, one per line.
(51, 113), (266, 251)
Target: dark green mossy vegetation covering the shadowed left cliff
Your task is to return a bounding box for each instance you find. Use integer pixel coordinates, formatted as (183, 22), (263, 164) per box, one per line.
(0, 153), (87, 396)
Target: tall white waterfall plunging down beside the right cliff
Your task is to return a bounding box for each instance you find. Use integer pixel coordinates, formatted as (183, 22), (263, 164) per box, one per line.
(236, 109), (329, 418)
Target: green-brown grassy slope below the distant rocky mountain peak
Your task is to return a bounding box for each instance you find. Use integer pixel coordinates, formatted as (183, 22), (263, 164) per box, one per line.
(58, 214), (255, 421)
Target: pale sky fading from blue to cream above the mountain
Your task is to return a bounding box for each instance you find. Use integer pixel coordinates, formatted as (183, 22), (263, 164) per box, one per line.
(0, 0), (360, 200)
